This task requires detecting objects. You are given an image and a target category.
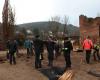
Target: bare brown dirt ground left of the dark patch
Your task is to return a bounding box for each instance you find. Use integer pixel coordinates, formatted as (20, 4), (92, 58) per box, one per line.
(0, 50), (48, 80)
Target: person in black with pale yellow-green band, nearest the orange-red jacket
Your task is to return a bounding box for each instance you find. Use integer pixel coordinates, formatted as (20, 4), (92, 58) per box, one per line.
(63, 37), (73, 69)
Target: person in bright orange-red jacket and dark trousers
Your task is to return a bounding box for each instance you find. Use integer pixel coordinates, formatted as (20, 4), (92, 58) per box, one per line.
(83, 36), (93, 64)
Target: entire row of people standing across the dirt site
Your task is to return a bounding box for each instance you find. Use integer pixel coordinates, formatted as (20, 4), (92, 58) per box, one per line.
(7, 35), (100, 69)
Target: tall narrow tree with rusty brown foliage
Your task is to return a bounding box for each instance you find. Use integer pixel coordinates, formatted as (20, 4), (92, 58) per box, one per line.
(2, 0), (15, 47)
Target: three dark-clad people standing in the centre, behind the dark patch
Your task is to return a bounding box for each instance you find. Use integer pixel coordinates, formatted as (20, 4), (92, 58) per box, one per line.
(33, 36), (73, 68)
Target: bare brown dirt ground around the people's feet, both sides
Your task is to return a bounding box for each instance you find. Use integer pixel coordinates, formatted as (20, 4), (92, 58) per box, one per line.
(0, 50), (100, 80)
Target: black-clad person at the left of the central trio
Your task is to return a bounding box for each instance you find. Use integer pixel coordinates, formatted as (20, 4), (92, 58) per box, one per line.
(33, 35), (43, 68)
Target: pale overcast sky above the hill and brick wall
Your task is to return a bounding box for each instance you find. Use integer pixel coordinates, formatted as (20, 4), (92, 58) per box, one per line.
(0, 0), (100, 26)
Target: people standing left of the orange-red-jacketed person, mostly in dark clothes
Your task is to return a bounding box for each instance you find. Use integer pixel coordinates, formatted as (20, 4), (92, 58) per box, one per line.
(7, 35), (73, 68)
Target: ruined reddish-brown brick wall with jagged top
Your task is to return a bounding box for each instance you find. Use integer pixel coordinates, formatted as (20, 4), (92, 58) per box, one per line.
(79, 15), (100, 43)
